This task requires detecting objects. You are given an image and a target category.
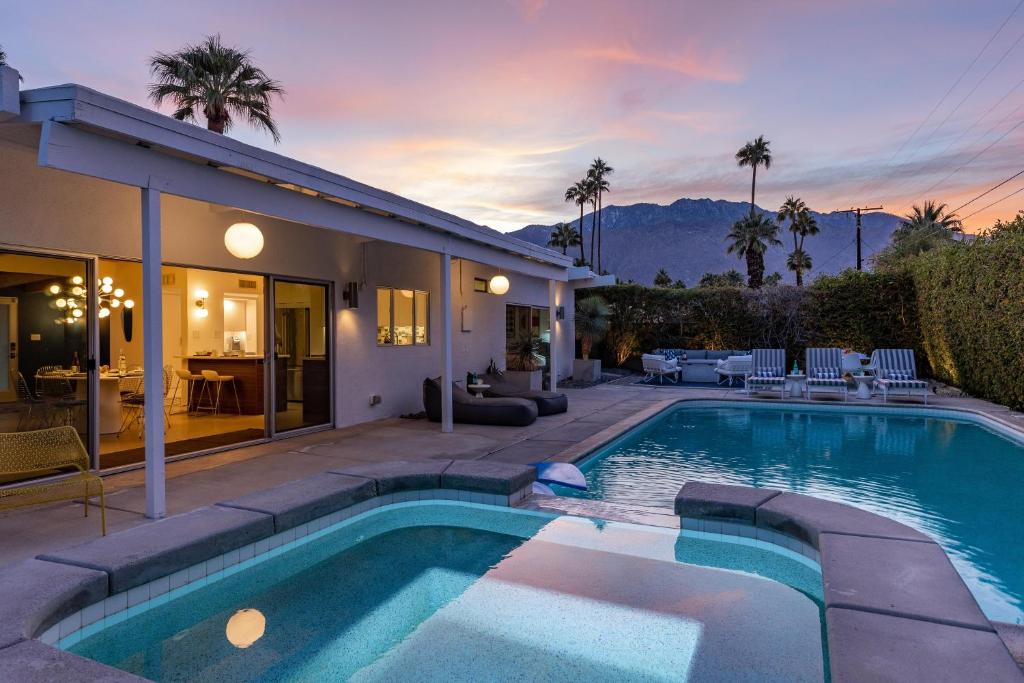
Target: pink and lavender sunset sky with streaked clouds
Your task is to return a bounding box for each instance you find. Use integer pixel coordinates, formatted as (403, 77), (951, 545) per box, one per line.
(6, 0), (1024, 230)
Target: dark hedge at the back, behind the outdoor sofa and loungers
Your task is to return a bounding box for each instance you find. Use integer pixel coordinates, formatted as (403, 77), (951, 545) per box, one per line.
(578, 271), (921, 374)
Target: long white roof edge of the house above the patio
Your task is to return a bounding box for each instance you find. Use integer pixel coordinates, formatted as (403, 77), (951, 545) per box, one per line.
(14, 84), (572, 268)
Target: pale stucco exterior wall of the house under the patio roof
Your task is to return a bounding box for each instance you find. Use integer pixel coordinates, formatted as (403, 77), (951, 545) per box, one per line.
(0, 129), (572, 425)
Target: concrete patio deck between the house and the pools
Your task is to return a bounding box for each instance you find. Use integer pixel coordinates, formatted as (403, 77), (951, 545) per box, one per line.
(0, 383), (1024, 566)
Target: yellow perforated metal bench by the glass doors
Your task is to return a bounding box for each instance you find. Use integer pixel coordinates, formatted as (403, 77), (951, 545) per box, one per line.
(0, 427), (106, 536)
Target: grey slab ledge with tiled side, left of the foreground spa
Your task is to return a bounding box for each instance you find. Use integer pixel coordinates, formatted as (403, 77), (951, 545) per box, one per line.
(0, 460), (537, 683)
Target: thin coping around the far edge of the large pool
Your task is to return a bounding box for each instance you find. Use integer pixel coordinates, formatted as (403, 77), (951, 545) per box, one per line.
(549, 395), (1024, 465)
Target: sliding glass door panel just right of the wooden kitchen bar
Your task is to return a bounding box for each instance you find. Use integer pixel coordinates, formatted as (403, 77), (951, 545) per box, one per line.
(273, 279), (333, 433)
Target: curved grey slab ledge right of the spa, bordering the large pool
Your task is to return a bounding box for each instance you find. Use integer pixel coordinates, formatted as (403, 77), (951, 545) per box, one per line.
(675, 482), (1024, 682)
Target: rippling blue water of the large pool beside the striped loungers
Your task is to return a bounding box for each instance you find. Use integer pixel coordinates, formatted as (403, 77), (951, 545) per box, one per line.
(558, 404), (1024, 623)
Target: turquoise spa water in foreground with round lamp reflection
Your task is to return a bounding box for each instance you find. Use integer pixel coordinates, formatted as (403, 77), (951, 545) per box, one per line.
(70, 502), (826, 682)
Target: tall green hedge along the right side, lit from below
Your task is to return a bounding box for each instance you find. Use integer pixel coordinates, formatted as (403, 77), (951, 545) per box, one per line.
(909, 234), (1024, 409)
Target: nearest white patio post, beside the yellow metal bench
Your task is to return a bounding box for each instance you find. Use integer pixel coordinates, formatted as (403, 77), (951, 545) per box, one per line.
(142, 187), (167, 519)
